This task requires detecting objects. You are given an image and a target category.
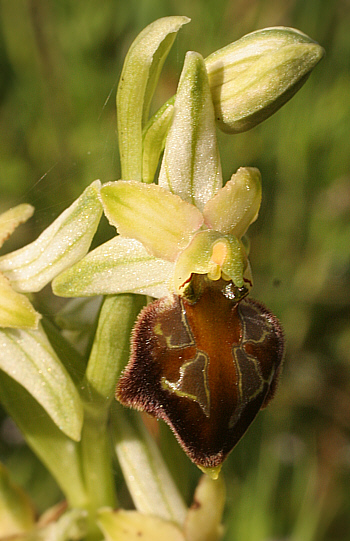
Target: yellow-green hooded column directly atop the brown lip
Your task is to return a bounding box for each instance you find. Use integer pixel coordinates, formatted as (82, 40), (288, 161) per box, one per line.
(174, 231), (250, 294)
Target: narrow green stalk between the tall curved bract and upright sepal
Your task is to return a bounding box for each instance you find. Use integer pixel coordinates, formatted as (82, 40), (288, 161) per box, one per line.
(142, 99), (174, 183)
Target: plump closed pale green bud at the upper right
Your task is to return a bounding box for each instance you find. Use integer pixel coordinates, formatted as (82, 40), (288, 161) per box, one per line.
(205, 27), (324, 133)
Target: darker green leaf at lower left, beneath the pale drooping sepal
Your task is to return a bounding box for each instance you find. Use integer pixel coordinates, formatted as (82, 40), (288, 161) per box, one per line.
(0, 370), (88, 508)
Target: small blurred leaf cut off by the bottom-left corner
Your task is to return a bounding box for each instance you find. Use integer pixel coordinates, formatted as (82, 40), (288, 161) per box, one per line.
(0, 464), (35, 538)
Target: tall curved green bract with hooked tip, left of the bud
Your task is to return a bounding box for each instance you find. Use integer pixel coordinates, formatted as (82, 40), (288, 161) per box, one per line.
(117, 16), (190, 180)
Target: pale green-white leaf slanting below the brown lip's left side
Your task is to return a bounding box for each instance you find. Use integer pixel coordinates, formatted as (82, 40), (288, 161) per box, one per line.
(112, 404), (186, 526)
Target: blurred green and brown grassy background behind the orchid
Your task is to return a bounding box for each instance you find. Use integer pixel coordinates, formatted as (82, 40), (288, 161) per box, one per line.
(0, 0), (350, 541)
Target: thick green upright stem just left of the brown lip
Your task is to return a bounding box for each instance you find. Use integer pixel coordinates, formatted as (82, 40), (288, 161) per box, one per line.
(81, 294), (145, 541)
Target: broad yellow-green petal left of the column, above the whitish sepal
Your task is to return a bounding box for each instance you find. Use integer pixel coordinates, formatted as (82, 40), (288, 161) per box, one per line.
(101, 181), (203, 261)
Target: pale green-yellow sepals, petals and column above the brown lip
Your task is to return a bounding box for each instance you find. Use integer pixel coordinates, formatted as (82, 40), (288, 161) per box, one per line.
(53, 53), (261, 298)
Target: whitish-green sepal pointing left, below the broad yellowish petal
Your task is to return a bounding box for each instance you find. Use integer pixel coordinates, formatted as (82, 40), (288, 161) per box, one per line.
(52, 236), (174, 297)
